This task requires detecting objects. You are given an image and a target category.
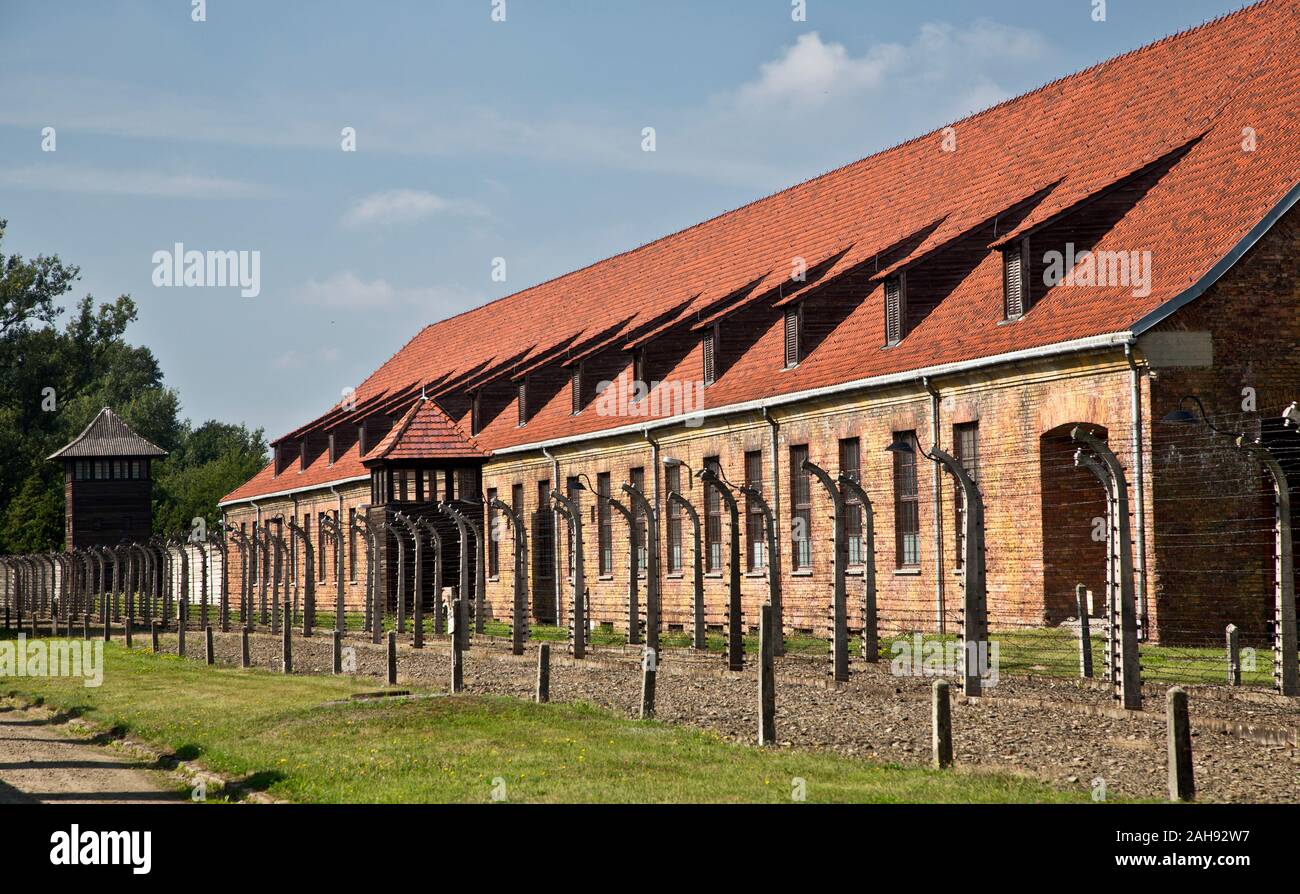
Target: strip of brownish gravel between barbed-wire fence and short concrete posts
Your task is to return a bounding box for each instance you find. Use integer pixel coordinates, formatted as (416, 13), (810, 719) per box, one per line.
(144, 632), (1300, 803)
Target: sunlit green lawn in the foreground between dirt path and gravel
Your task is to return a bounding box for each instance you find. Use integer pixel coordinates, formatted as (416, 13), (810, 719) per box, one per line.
(0, 636), (1088, 803)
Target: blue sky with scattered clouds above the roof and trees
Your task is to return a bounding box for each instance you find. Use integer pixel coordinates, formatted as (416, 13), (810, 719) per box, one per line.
(0, 0), (1236, 437)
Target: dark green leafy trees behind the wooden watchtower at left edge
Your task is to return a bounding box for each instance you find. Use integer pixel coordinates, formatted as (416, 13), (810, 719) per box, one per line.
(0, 221), (267, 554)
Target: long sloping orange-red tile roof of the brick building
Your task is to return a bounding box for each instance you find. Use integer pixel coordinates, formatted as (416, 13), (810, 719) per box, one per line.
(218, 0), (1300, 502)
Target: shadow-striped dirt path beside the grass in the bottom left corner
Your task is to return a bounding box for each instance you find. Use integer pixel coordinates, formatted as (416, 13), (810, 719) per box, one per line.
(0, 704), (185, 804)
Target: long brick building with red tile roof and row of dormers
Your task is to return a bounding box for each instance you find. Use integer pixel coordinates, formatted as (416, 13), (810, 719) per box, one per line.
(222, 0), (1300, 641)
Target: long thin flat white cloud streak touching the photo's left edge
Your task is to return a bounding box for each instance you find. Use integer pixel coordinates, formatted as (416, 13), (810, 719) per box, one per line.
(0, 162), (265, 199)
